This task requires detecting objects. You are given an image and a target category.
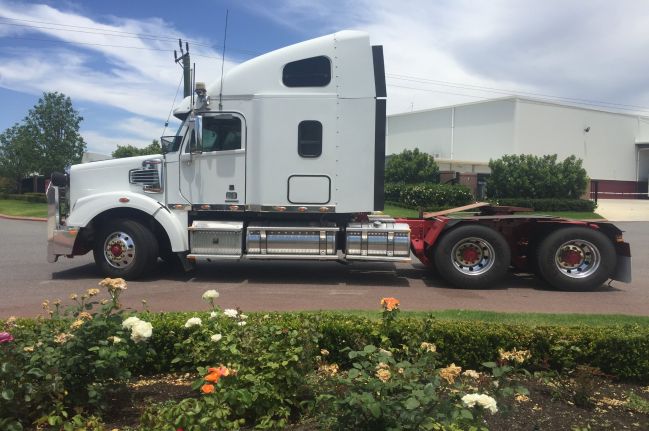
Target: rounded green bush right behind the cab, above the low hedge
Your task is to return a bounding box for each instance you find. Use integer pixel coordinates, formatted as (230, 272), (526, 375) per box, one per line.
(385, 148), (439, 184)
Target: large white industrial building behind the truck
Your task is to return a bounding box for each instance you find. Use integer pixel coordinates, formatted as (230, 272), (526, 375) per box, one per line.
(386, 97), (649, 198)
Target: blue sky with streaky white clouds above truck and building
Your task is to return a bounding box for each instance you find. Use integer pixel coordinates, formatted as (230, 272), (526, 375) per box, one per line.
(0, 0), (649, 154)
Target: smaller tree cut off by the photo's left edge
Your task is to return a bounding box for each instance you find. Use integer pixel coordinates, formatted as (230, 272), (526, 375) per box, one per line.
(0, 123), (39, 193)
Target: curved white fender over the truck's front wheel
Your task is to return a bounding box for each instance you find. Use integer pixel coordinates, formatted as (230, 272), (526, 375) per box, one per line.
(67, 191), (188, 252)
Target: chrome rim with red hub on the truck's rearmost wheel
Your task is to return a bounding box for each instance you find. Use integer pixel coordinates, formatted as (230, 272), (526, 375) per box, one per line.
(554, 239), (602, 278)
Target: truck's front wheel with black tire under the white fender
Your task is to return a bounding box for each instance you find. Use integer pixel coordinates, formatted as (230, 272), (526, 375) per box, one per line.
(93, 219), (158, 280)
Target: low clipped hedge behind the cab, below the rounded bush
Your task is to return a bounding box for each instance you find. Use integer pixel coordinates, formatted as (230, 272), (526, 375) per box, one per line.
(385, 183), (473, 209)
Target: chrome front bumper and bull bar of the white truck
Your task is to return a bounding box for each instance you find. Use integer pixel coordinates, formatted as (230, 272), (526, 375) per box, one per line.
(46, 184), (79, 263)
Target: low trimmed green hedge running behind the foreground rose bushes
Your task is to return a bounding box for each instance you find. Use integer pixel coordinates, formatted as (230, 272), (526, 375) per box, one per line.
(139, 312), (649, 383)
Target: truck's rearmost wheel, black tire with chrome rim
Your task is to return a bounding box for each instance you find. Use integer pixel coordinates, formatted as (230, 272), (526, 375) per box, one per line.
(536, 226), (617, 292)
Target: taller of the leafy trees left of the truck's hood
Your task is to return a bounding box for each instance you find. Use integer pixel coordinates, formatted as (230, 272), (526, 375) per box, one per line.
(21, 92), (86, 175)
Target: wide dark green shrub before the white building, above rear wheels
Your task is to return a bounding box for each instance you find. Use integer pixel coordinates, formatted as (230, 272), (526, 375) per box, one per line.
(487, 154), (588, 199)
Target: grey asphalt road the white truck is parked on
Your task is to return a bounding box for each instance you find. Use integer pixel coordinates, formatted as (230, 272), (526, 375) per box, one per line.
(0, 219), (649, 318)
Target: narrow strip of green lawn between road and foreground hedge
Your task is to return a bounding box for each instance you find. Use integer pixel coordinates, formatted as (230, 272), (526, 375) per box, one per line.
(306, 310), (649, 327)
